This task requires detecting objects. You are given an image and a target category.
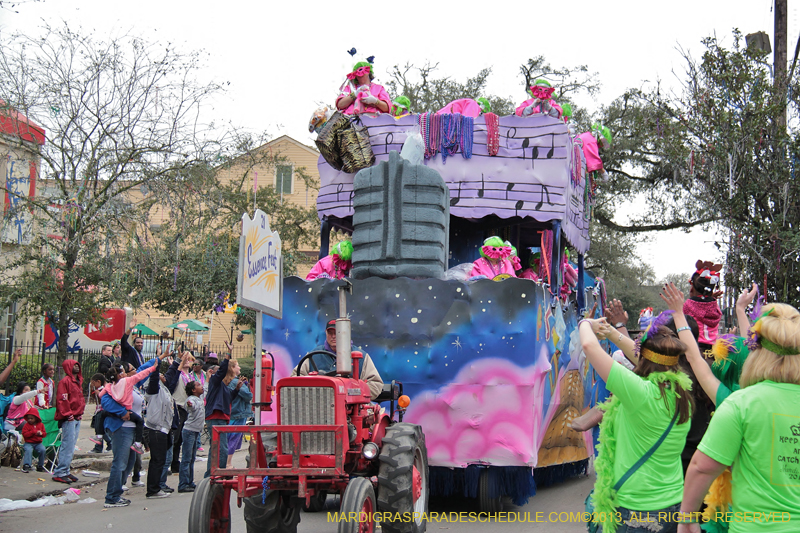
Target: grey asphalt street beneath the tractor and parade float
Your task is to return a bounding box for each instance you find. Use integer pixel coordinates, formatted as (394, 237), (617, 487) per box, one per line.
(0, 450), (594, 533)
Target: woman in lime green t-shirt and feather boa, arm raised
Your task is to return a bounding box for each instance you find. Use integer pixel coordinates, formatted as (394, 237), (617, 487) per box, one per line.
(579, 313), (697, 533)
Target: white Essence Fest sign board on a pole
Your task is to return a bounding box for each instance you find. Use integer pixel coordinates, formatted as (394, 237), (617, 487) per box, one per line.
(236, 209), (283, 319)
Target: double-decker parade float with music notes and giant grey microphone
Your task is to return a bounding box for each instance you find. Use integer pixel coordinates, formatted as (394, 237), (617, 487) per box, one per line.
(262, 106), (605, 511)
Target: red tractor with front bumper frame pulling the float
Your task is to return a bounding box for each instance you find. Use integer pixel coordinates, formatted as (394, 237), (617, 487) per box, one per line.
(189, 287), (428, 533)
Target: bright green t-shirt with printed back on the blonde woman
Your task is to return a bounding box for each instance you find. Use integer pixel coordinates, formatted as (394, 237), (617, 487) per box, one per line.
(697, 381), (800, 533)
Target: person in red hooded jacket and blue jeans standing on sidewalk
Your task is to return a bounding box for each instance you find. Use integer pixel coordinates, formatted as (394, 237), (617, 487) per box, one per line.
(53, 359), (86, 483)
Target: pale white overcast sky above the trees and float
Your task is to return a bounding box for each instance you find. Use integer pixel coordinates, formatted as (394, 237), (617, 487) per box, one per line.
(0, 0), (800, 278)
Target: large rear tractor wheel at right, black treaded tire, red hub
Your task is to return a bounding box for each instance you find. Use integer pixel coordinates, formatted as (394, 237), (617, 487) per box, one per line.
(378, 423), (429, 533)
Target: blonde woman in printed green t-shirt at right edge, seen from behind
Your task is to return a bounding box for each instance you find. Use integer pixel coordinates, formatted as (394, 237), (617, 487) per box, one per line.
(678, 304), (800, 533)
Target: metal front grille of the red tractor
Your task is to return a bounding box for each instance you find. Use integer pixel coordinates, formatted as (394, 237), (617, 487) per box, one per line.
(281, 387), (336, 455)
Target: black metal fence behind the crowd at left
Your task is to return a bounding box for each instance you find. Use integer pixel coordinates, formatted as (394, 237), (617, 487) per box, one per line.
(0, 337), (253, 395)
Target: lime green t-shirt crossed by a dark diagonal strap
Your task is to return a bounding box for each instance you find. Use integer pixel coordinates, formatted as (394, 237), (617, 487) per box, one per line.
(606, 365), (690, 511)
